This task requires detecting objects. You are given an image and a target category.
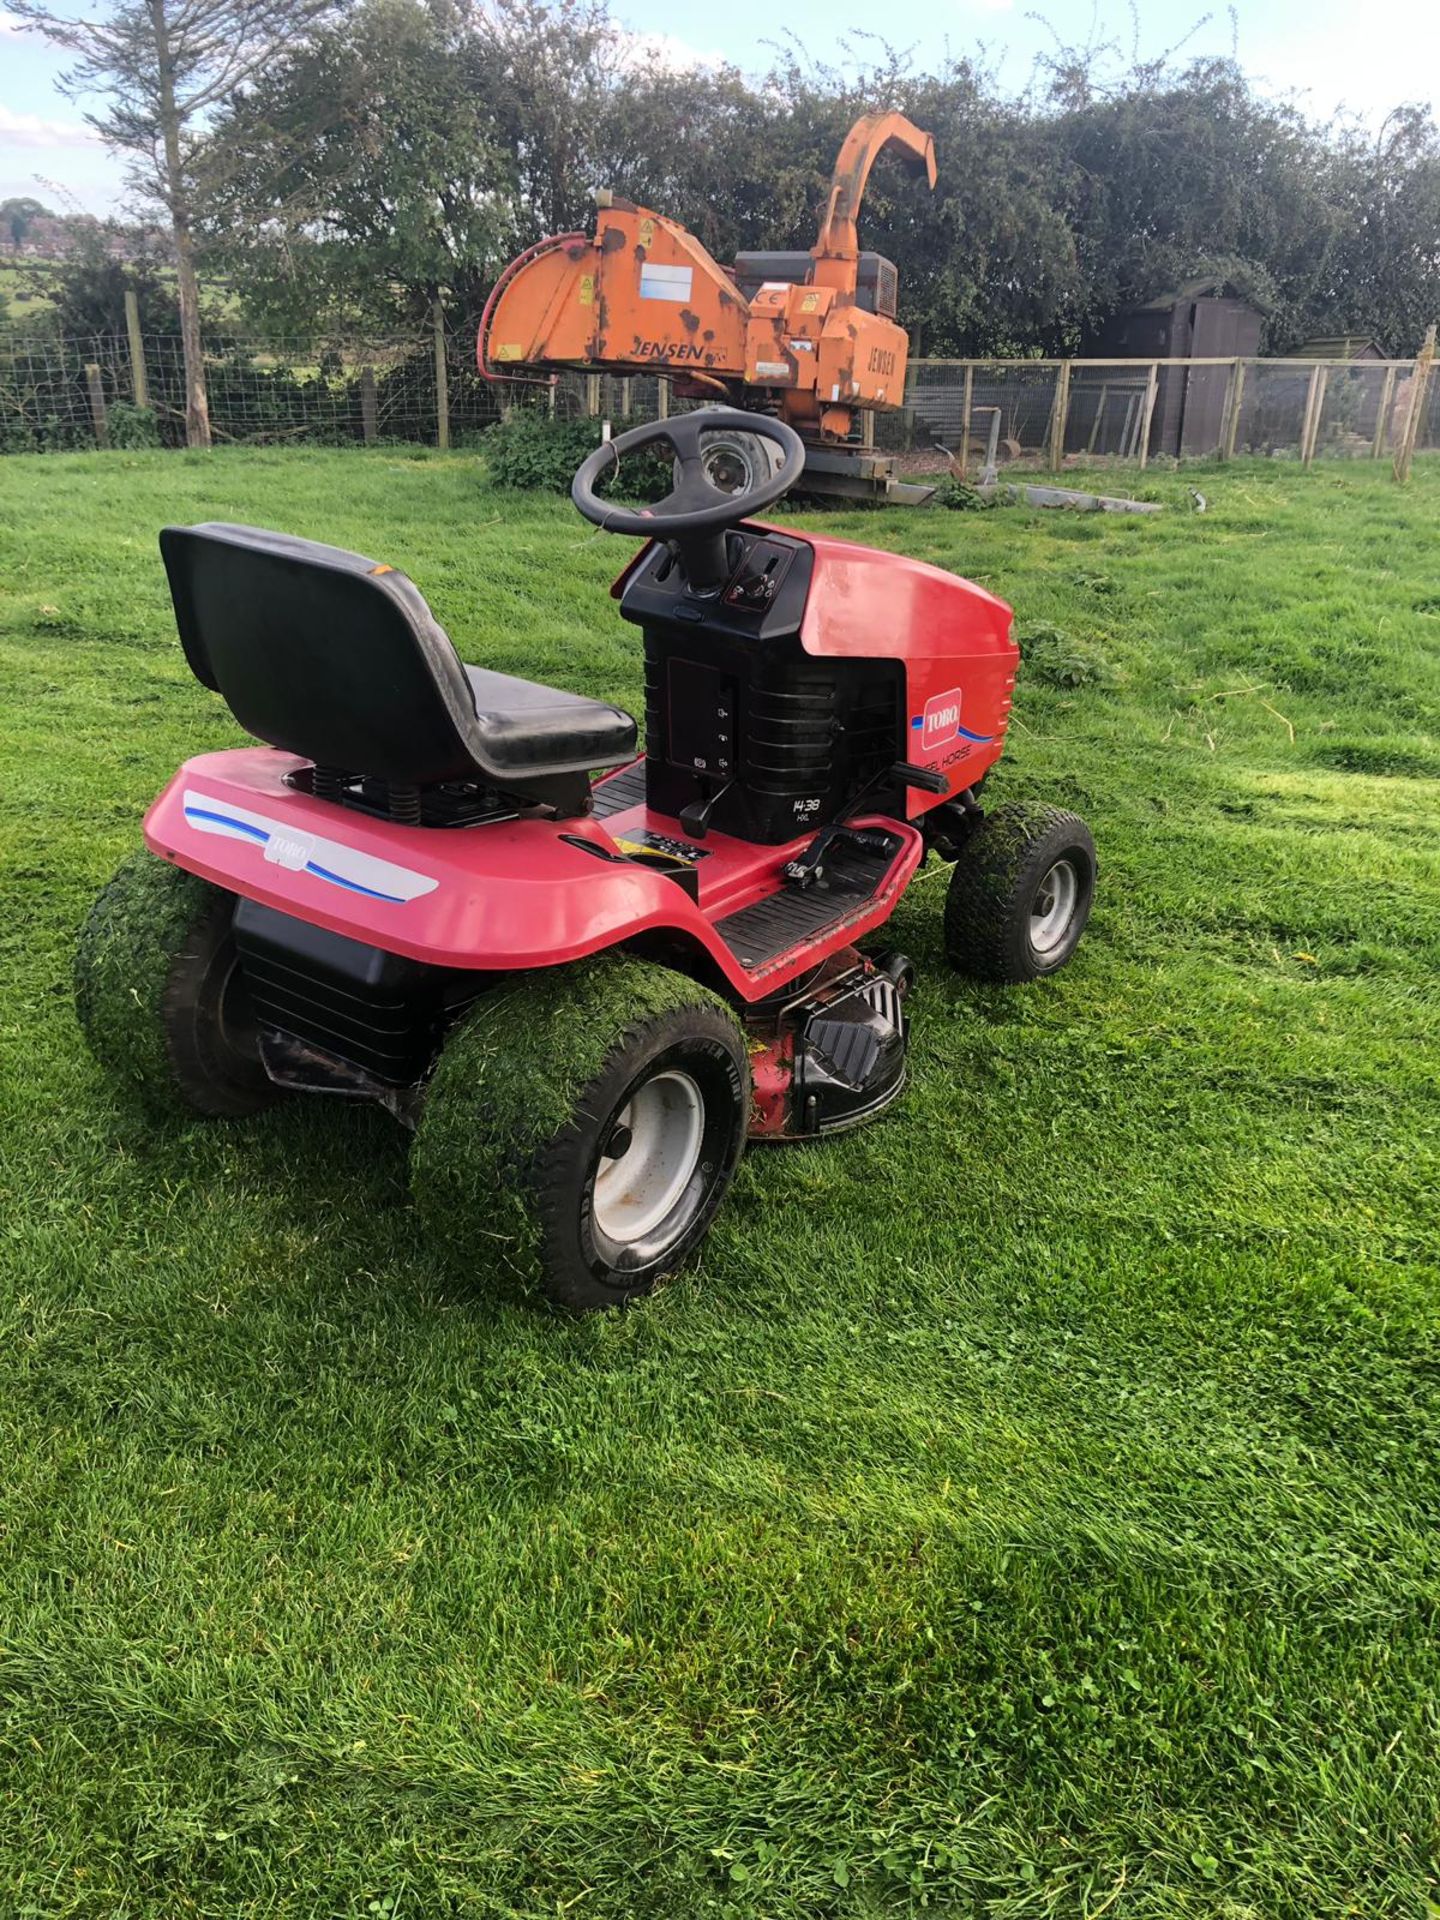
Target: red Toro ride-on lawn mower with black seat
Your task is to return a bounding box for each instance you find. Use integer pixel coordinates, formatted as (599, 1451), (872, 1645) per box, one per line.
(77, 409), (1094, 1309)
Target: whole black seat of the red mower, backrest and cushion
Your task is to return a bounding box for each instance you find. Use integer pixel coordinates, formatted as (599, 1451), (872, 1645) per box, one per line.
(159, 522), (636, 808)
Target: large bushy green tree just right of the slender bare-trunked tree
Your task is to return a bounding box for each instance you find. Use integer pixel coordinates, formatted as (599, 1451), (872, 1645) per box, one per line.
(211, 0), (664, 324)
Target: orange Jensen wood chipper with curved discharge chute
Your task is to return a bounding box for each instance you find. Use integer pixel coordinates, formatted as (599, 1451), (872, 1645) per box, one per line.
(478, 113), (935, 497)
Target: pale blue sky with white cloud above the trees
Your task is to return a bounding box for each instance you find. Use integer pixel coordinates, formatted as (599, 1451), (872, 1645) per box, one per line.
(0, 0), (1440, 215)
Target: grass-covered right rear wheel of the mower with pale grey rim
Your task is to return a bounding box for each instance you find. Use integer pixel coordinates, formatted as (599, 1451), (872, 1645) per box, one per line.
(411, 954), (751, 1313)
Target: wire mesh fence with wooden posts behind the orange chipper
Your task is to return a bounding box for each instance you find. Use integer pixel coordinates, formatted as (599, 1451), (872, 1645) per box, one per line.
(0, 330), (1440, 474)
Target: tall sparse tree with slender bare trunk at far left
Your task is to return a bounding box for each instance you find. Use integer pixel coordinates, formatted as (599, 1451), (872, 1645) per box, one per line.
(10, 0), (328, 447)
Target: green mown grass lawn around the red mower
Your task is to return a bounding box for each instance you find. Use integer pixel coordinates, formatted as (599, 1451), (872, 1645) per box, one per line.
(0, 449), (1440, 1920)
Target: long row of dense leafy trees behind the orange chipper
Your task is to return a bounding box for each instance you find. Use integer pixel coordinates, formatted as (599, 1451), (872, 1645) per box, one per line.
(209, 0), (1440, 355)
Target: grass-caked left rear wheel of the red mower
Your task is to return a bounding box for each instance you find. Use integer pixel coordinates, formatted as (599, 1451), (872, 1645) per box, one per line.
(75, 852), (275, 1119)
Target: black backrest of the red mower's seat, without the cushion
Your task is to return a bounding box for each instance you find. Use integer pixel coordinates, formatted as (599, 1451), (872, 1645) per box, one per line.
(159, 522), (478, 787)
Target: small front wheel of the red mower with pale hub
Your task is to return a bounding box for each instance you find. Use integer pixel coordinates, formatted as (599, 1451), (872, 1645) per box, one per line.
(945, 806), (1094, 981)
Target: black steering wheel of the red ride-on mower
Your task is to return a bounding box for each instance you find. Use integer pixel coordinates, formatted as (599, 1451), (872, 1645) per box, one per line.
(570, 407), (804, 591)
